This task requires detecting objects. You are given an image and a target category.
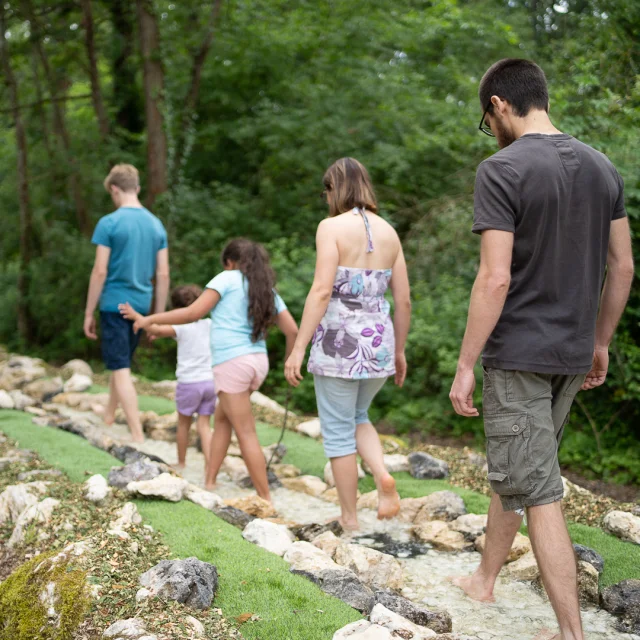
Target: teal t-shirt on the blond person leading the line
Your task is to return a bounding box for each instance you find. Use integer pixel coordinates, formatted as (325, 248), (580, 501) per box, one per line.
(91, 207), (167, 314)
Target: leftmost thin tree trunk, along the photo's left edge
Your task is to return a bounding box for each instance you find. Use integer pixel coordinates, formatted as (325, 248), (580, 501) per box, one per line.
(0, 2), (33, 344)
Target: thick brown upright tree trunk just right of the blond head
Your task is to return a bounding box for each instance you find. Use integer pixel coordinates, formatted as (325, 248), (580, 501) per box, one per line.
(136, 0), (167, 207)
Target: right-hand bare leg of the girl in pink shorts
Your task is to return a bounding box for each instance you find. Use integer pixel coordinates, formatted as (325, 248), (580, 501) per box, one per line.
(219, 391), (271, 502)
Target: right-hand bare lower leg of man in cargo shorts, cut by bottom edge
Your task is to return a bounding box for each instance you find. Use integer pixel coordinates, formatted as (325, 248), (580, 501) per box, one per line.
(527, 502), (584, 640)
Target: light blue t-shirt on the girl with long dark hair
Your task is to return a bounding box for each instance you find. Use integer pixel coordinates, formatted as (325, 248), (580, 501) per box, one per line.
(207, 269), (287, 367)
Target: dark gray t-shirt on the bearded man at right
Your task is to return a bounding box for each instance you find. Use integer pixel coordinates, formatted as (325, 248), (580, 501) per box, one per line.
(473, 134), (626, 375)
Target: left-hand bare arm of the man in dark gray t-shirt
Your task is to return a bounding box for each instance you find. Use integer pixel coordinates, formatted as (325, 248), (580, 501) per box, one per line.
(449, 230), (513, 417)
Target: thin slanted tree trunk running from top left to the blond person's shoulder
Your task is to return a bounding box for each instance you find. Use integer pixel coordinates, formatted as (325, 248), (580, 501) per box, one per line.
(22, 0), (91, 236)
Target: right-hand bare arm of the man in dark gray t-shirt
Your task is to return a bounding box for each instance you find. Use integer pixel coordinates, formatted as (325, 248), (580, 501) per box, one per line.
(582, 218), (634, 391)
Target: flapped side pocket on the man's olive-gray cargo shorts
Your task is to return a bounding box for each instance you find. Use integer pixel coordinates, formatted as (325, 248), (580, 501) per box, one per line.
(484, 413), (535, 496)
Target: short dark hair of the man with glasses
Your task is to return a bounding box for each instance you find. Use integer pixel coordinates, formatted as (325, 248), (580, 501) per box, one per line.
(478, 58), (549, 118)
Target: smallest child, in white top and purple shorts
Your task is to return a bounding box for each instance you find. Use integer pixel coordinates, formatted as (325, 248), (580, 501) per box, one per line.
(120, 285), (216, 471)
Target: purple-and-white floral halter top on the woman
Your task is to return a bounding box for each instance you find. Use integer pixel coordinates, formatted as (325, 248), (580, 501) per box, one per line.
(307, 209), (395, 380)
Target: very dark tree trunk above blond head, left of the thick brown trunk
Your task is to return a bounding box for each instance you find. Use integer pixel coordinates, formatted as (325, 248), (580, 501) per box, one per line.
(106, 0), (144, 133)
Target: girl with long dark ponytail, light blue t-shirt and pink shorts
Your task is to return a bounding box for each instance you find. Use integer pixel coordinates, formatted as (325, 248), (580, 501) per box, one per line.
(134, 238), (298, 500)
